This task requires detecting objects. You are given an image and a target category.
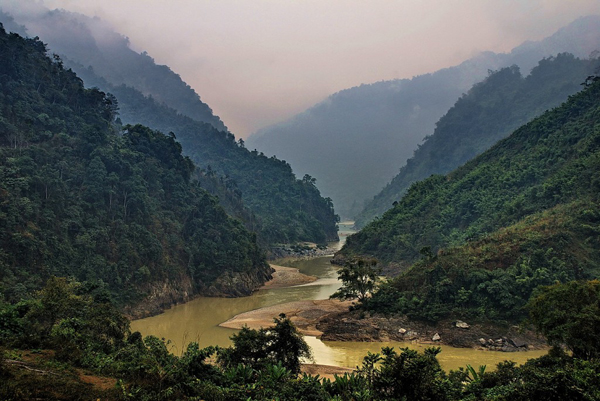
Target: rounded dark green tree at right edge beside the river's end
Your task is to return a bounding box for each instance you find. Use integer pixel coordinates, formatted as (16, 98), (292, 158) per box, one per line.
(526, 280), (600, 360)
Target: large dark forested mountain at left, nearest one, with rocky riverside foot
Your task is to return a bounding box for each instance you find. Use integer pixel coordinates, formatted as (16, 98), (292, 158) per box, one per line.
(0, 25), (270, 308)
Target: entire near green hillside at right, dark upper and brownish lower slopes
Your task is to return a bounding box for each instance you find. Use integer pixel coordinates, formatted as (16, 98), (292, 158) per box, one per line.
(337, 69), (600, 322)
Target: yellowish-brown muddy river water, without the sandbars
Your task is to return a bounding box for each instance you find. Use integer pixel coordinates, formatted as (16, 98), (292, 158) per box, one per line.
(131, 223), (546, 370)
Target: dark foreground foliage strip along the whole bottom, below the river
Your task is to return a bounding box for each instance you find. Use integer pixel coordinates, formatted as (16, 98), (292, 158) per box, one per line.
(0, 277), (600, 401)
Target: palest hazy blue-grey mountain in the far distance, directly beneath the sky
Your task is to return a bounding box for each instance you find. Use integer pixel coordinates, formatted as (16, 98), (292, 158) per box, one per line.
(247, 16), (600, 217)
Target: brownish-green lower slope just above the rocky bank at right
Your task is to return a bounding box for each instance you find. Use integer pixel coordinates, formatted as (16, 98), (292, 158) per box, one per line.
(364, 200), (600, 322)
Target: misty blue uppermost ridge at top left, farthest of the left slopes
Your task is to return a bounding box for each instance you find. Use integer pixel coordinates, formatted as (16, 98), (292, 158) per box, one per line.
(0, 5), (227, 130)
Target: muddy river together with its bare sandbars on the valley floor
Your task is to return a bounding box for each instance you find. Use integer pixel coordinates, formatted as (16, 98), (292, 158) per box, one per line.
(131, 223), (547, 371)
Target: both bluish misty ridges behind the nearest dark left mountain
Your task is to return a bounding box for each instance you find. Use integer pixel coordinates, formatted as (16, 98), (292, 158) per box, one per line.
(0, 6), (337, 245)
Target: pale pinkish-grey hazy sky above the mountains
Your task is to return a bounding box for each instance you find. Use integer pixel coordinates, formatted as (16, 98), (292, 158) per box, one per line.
(27, 0), (600, 137)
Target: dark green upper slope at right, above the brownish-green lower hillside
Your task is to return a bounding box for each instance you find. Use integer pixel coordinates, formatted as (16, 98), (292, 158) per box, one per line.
(336, 76), (600, 269)
